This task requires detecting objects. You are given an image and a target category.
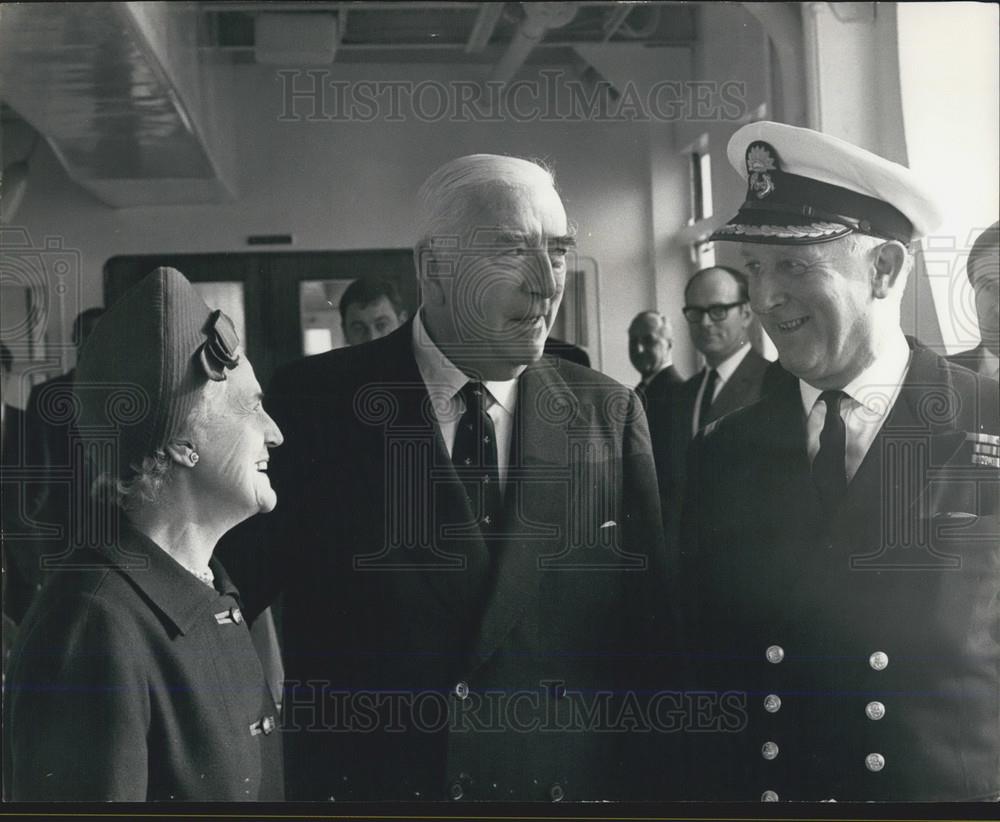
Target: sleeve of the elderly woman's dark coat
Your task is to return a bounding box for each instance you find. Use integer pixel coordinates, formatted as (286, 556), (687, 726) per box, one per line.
(4, 597), (150, 802)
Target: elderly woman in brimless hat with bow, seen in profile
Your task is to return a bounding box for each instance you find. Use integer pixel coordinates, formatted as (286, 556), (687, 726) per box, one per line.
(3, 268), (282, 801)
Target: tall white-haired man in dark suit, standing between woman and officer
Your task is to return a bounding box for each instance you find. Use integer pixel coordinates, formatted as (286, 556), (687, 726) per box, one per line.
(223, 155), (679, 801)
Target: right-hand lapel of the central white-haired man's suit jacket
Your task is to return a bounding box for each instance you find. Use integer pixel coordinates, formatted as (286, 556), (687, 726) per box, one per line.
(469, 360), (592, 667)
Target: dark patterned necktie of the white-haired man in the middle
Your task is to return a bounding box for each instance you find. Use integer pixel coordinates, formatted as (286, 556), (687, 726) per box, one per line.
(451, 382), (503, 534)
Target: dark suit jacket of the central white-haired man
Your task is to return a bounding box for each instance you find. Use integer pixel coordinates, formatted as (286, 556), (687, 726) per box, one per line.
(223, 322), (678, 801)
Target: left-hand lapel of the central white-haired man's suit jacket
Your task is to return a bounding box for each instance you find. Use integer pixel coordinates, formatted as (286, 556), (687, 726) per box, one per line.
(350, 320), (489, 618)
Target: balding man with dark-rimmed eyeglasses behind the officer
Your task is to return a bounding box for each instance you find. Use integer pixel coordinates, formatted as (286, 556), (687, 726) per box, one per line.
(650, 266), (769, 540)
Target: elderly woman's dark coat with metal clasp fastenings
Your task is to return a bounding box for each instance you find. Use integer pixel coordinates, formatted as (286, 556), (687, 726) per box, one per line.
(3, 525), (282, 801)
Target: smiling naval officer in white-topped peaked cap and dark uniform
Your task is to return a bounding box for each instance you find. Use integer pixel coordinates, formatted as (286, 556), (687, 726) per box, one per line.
(682, 122), (1000, 801)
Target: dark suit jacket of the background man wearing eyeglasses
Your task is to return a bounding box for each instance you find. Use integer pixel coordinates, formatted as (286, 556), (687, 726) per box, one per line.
(649, 348), (771, 540)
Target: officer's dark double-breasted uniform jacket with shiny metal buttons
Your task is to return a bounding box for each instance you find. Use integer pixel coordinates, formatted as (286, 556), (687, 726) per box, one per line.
(682, 348), (1000, 801)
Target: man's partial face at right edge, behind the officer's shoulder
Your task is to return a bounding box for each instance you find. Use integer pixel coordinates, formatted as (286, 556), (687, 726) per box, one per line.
(948, 223), (1000, 380)
